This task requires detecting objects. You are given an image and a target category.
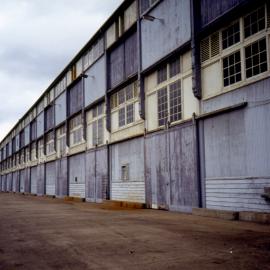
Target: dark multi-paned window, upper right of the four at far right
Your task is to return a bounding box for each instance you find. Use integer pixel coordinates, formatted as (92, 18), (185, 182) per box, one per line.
(244, 6), (265, 38)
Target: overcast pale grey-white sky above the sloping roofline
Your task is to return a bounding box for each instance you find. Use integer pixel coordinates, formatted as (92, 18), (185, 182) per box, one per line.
(0, 0), (122, 140)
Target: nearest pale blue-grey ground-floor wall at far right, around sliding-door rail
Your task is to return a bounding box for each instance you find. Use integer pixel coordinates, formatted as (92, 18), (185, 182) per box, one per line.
(201, 79), (270, 212)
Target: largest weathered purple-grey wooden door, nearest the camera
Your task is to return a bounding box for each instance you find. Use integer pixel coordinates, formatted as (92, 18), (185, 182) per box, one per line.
(145, 122), (199, 212)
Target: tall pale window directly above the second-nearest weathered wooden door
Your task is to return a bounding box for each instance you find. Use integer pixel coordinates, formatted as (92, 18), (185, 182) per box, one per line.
(92, 104), (104, 146)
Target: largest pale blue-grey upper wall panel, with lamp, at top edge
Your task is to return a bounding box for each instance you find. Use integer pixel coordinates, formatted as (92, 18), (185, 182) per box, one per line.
(141, 0), (191, 69)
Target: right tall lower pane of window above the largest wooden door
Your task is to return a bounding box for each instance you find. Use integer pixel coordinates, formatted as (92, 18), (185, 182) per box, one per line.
(170, 80), (182, 122)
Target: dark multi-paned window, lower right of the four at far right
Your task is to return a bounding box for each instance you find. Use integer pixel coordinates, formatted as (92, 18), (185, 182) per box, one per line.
(245, 38), (267, 78)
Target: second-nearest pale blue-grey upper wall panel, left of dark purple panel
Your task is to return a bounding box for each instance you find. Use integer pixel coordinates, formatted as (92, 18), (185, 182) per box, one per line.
(84, 56), (106, 106)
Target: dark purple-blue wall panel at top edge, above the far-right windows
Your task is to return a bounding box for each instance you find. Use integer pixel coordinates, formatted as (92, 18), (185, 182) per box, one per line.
(201, 0), (245, 26)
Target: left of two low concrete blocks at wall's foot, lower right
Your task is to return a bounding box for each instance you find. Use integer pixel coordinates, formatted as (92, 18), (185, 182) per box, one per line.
(192, 208), (239, 220)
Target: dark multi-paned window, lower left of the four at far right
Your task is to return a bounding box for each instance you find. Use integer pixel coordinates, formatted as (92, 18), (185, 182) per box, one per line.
(223, 51), (241, 86)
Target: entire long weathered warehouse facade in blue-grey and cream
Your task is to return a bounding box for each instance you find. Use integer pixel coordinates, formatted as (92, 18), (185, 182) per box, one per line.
(0, 0), (270, 212)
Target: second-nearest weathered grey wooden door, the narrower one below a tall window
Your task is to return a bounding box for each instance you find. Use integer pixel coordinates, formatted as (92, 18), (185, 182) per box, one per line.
(85, 147), (108, 202)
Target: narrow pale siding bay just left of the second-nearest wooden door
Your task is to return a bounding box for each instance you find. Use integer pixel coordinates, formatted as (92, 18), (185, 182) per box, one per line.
(69, 154), (85, 198)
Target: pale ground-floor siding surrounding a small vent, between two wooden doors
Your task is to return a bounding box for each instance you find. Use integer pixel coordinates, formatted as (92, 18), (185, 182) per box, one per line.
(110, 138), (145, 202)
